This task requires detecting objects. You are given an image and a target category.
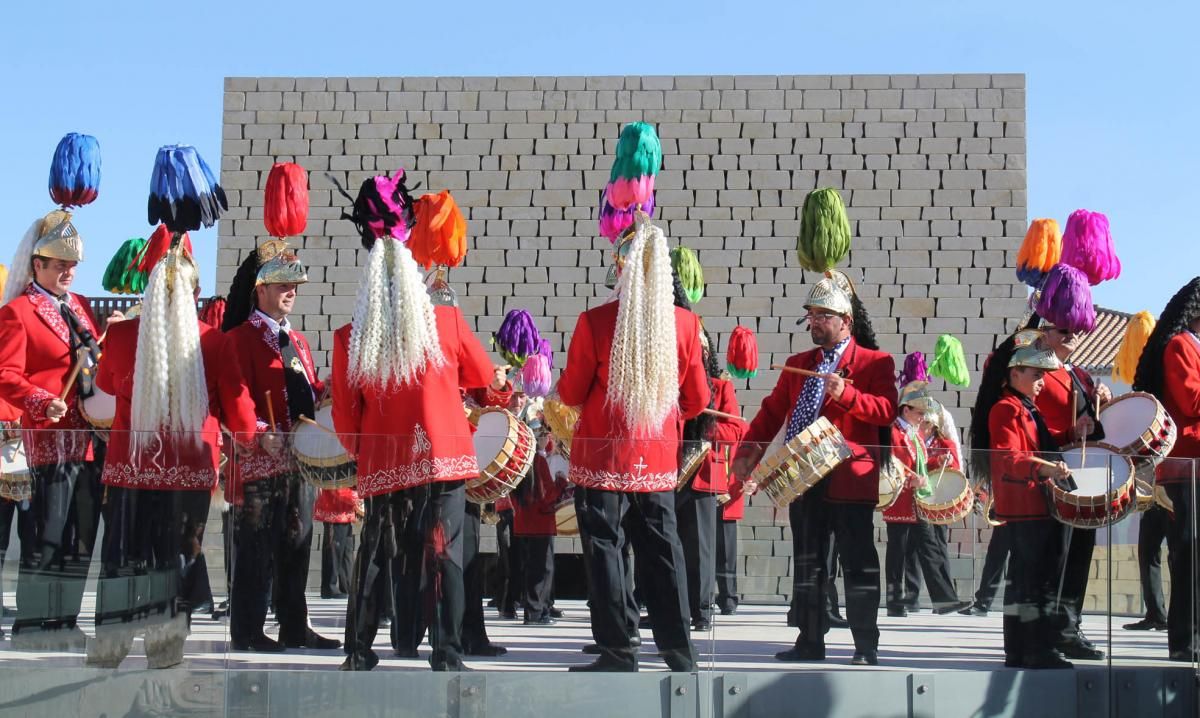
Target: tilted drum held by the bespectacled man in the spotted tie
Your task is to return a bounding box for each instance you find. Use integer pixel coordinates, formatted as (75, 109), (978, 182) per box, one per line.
(750, 417), (851, 508)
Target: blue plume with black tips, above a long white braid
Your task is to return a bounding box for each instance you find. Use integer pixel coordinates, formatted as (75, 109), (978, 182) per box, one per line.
(146, 144), (229, 233)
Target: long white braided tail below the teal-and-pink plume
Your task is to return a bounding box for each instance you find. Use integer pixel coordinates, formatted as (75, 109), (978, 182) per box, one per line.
(607, 221), (679, 436)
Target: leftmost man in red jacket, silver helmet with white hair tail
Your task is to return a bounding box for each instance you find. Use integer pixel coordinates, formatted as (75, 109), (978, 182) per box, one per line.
(0, 210), (112, 647)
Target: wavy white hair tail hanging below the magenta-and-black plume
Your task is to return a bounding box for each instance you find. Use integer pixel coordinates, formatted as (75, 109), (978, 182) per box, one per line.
(348, 237), (445, 387)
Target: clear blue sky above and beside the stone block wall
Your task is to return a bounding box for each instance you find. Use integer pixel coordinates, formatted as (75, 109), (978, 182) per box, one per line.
(0, 0), (1200, 315)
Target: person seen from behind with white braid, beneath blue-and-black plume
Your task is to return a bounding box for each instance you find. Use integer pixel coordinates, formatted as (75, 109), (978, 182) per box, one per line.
(88, 240), (256, 668)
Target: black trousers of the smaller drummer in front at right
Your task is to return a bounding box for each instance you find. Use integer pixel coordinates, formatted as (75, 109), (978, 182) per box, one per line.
(1003, 519), (1067, 660)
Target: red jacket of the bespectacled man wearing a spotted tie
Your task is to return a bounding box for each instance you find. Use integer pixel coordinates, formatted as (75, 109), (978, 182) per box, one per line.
(738, 339), (896, 505)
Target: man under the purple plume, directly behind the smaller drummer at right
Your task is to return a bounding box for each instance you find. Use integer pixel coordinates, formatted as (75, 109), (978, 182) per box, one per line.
(1031, 319), (1112, 660)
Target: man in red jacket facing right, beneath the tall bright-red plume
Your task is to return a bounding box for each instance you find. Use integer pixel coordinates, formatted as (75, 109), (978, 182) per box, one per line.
(221, 239), (341, 652)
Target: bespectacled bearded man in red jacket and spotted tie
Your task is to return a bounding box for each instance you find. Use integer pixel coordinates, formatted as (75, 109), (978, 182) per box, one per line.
(733, 273), (896, 665)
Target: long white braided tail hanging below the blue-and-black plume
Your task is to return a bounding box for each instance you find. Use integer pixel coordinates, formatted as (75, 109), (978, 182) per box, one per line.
(130, 257), (209, 462)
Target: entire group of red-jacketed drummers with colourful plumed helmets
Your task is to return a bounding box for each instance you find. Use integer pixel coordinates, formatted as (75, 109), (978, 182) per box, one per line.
(0, 122), (1200, 671)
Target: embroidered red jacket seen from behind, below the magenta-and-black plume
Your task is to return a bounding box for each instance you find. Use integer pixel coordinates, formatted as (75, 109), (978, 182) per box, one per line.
(332, 306), (492, 497)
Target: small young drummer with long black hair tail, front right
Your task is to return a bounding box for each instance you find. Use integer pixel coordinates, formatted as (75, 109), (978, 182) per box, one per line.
(971, 330), (1072, 669)
